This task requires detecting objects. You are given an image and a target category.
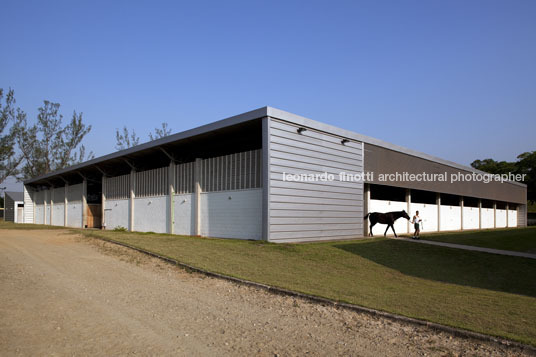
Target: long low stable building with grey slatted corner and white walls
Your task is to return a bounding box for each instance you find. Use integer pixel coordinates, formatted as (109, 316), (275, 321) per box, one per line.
(24, 107), (527, 242)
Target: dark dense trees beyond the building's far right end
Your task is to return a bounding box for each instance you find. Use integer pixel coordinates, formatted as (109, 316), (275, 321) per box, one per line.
(471, 151), (536, 203)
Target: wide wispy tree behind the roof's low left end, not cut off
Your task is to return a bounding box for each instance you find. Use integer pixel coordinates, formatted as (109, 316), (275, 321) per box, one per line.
(15, 100), (94, 178)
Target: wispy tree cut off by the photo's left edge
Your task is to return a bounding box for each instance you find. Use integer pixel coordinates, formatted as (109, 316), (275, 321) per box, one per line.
(0, 88), (26, 184)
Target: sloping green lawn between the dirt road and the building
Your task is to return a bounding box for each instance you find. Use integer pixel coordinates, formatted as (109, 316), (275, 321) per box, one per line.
(0, 225), (536, 345)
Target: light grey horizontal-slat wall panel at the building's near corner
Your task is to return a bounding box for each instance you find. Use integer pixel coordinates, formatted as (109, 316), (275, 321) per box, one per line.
(268, 119), (363, 242)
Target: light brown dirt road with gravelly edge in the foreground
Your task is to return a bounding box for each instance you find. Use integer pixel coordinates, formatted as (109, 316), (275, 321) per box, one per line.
(0, 230), (532, 356)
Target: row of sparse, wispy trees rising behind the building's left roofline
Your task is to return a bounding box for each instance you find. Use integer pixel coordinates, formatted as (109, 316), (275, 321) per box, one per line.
(0, 88), (171, 184)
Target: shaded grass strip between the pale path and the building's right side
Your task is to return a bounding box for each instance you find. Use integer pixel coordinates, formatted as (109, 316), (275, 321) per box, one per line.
(414, 227), (536, 254)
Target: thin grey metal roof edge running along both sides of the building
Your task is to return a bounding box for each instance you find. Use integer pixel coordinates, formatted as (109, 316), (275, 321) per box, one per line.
(24, 107), (526, 187)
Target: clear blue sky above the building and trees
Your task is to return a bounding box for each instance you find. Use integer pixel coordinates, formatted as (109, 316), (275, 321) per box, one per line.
(0, 0), (536, 192)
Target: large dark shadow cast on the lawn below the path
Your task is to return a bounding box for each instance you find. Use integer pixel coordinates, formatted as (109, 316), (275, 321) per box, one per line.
(334, 238), (536, 297)
